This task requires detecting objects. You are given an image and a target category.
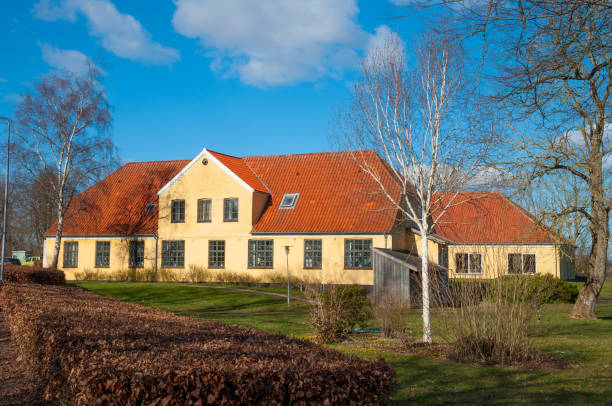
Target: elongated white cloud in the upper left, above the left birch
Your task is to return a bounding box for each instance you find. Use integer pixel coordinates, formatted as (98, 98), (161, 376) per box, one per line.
(34, 0), (180, 65)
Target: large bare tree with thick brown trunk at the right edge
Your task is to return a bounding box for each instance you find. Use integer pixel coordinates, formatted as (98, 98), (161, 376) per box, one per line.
(420, 0), (612, 319)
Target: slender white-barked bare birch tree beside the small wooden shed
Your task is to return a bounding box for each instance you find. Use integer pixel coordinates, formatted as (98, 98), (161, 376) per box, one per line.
(339, 30), (486, 343)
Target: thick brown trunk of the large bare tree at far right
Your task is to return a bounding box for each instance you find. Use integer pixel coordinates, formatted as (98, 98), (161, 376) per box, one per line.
(570, 151), (610, 319)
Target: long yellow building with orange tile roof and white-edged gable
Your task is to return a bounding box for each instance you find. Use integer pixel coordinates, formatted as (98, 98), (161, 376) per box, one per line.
(43, 149), (573, 285)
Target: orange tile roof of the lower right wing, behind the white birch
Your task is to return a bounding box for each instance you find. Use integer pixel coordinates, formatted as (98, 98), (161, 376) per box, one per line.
(432, 191), (572, 245)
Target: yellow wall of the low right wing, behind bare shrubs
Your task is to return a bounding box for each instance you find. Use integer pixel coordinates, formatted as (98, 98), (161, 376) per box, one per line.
(448, 245), (574, 279)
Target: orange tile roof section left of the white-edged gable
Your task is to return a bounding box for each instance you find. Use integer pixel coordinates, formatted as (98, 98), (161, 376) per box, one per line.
(45, 160), (189, 235)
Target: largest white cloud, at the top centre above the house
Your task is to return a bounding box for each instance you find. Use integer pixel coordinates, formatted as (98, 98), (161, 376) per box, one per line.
(172, 0), (369, 87)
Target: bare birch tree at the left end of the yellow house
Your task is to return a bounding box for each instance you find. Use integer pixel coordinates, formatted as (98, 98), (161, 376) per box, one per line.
(16, 66), (114, 267)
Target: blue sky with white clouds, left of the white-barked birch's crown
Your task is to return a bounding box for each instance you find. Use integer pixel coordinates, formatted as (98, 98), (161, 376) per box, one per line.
(0, 0), (421, 161)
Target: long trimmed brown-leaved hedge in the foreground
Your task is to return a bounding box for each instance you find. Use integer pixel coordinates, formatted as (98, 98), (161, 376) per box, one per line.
(0, 284), (394, 405)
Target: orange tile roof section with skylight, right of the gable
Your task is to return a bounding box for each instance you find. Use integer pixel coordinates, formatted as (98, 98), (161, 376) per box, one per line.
(244, 151), (400, 233)
